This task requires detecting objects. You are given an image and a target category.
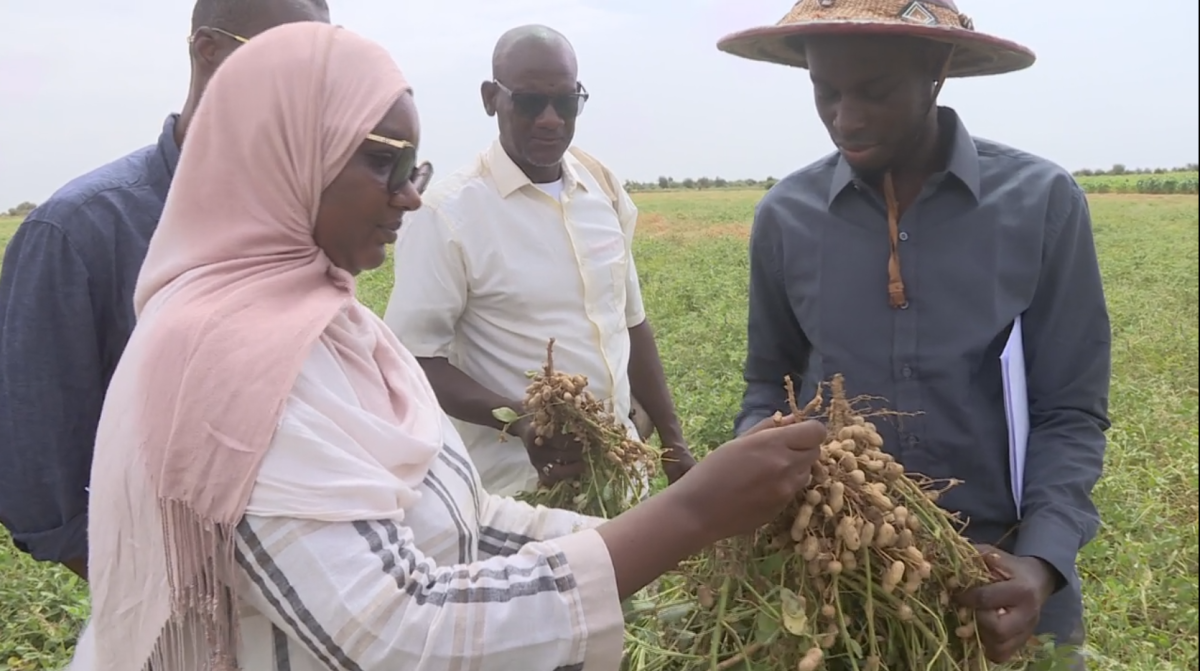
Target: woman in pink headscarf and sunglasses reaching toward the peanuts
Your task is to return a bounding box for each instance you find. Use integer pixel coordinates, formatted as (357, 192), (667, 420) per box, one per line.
(72, 23), (823, 671)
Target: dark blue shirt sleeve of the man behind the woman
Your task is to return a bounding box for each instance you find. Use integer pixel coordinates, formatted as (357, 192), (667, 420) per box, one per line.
(0, 220), (104, 562)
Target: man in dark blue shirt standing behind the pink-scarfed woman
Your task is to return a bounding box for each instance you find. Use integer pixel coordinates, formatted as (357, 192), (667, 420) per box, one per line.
(0, 0), (329, 579)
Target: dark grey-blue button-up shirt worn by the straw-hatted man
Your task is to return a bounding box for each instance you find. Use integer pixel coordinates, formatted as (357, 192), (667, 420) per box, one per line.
(736, 108), (1111, 642)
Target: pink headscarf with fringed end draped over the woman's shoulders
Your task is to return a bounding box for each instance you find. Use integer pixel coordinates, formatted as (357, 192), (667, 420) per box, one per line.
(81, 23), (442, 671)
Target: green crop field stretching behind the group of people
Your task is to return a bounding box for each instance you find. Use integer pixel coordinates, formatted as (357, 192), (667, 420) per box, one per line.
(0, 190), (1200, 671)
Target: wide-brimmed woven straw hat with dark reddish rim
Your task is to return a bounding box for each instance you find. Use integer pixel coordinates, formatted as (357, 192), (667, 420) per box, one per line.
(716, 0), (1036, 77)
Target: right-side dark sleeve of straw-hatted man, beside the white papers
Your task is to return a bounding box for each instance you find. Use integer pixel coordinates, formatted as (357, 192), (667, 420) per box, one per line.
(1015, 184), (1112, 589)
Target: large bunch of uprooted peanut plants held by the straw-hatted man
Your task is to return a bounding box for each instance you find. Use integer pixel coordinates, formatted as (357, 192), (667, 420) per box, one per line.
(635, 376), (1032, 671)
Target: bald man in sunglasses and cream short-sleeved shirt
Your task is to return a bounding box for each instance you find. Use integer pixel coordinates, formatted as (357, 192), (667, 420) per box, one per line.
(385, 26), (695, 495)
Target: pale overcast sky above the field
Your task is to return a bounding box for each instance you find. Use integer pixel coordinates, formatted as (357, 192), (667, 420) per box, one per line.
(0, 0), (1200, 209)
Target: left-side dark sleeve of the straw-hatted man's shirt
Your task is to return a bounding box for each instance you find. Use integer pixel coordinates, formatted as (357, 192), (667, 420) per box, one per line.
(733, 200), (811, 436)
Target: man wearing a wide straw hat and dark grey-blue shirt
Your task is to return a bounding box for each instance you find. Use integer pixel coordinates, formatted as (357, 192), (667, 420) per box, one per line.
(719, 0), (1111, 669)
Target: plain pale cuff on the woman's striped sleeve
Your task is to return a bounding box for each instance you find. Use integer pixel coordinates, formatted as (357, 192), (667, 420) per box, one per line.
(550, 529), (625, 669)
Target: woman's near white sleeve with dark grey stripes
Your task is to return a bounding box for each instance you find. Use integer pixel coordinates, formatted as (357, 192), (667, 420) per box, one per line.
(238, 516), (624, 671)
